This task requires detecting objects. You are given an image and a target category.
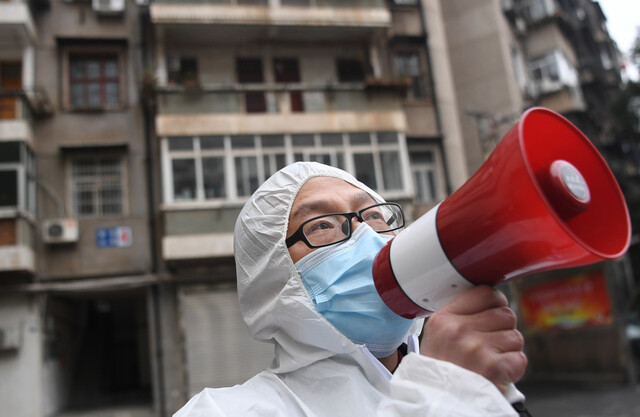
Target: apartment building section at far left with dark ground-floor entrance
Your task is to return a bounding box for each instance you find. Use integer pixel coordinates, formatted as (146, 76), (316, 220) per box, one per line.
(0, 0), (155, 416)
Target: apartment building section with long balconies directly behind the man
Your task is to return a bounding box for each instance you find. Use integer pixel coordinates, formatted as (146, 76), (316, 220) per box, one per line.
(148, 0), (463, 409)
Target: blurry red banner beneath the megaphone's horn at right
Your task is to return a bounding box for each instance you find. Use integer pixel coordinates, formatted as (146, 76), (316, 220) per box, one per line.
(520, 271), (613, 330)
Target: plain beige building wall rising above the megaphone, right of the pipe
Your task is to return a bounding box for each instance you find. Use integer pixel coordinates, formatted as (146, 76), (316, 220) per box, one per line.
(442, 0), (523, 172)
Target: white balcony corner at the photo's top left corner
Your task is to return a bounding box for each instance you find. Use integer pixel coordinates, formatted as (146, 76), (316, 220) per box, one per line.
(0, 0), (37, 48)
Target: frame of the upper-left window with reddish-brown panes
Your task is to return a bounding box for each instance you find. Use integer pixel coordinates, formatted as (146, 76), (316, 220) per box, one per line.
(61, 43), (127, 112)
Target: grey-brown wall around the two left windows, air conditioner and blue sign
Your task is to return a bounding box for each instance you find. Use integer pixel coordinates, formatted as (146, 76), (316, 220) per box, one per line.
(34, 0), (150, 280)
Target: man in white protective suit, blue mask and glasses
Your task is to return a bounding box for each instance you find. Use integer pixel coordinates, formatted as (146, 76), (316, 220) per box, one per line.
(174, 162), (527, 417)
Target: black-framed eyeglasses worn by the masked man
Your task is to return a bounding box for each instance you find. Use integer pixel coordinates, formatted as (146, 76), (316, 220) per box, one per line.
(285, 203), (404, 249)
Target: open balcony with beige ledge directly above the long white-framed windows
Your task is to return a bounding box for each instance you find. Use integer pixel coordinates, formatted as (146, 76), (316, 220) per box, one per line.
(156, 82), (406, 136)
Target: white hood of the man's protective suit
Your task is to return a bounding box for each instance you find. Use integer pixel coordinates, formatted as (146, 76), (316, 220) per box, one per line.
(234, 162), (422, 373)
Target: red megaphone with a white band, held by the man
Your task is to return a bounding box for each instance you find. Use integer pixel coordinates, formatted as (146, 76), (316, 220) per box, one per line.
(373, 107), (631, 318)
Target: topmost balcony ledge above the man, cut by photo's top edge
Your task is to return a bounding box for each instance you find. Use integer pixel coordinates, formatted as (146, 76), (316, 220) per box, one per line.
(150, 0), (391, 43)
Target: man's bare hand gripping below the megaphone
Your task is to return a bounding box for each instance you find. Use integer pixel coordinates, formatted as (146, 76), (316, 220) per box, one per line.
(420, 285), (527, 393)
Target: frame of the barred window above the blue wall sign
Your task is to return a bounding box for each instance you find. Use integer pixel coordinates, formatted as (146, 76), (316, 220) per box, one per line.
(65, 151), (129, 219)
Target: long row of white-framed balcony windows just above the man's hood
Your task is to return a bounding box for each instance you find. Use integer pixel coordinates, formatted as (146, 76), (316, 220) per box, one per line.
(162, 132), (409, 203)
